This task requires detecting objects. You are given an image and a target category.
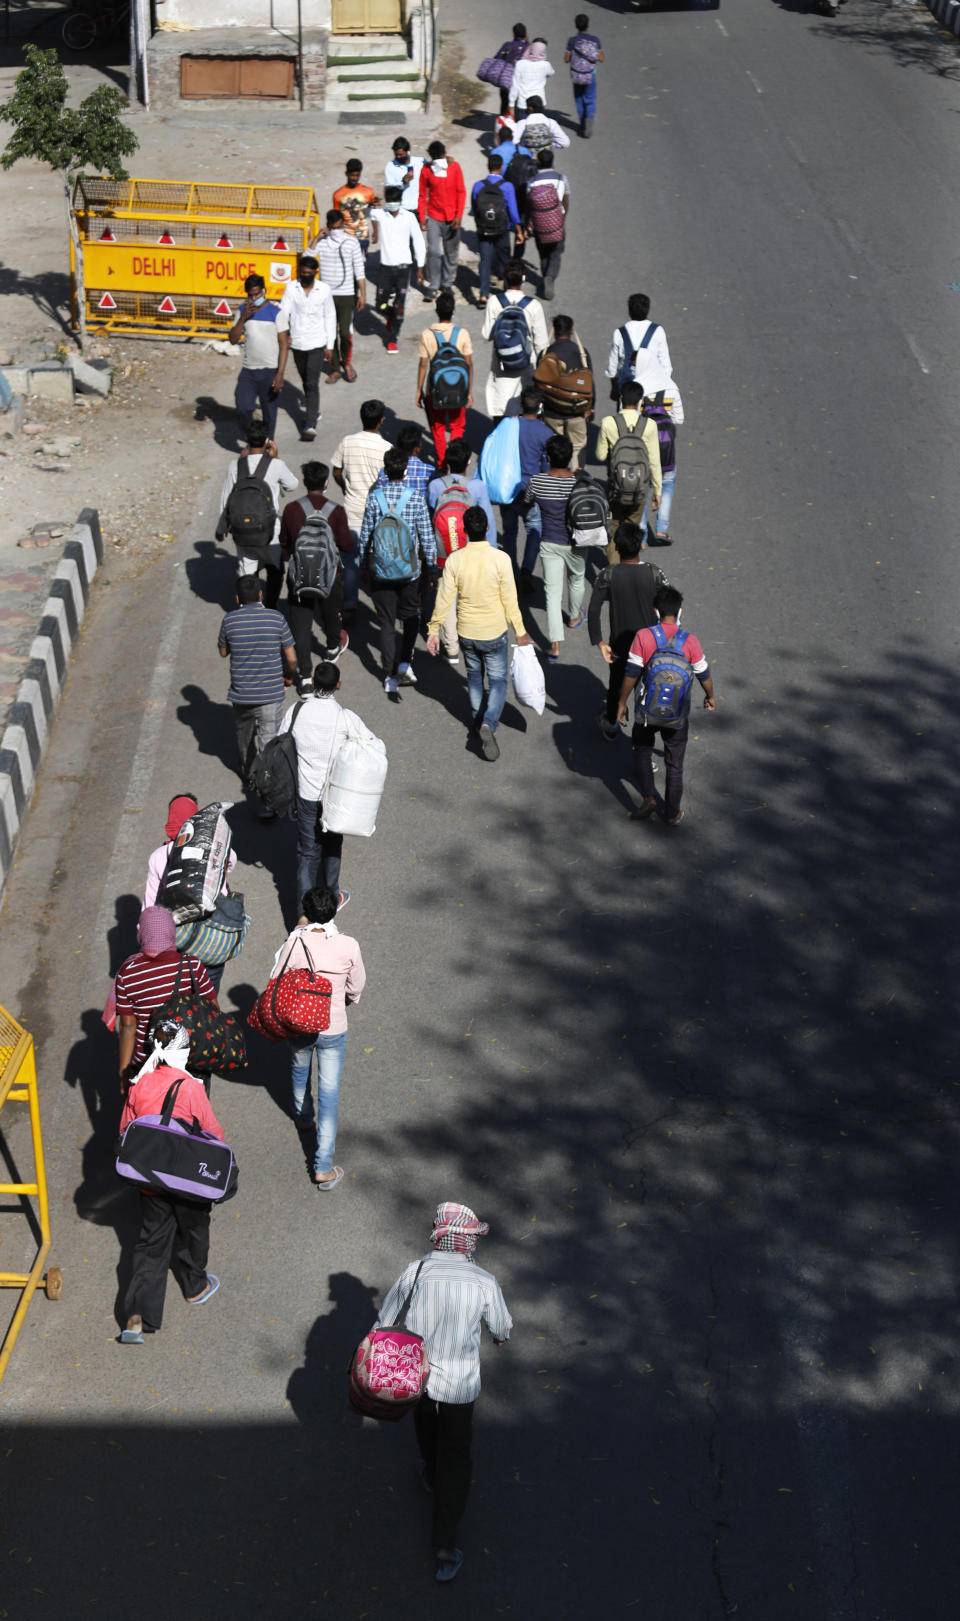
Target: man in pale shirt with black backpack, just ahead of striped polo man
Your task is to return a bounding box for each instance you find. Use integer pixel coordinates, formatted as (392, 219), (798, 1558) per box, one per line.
(216, 421), (297, 608)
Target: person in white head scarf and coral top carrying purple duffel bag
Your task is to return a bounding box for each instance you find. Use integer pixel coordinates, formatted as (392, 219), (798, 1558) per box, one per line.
(120, 1018), (224, 1345)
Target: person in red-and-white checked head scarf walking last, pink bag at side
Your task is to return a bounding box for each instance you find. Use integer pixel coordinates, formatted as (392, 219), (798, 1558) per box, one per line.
(373, 1201), (512, 1582)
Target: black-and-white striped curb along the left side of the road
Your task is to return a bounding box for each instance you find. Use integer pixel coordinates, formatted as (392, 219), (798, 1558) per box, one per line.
(0, 507), (104, 895)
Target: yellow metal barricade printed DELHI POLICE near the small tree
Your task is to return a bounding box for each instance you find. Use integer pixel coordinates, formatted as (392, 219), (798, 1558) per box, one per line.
(70, 175), (319, 337)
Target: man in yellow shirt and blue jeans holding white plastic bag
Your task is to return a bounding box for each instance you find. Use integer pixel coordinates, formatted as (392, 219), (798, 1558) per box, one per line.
(426, 507), (530, 760)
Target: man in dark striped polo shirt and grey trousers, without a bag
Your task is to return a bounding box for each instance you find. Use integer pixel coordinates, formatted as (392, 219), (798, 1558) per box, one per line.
(217, 574), (297, 822)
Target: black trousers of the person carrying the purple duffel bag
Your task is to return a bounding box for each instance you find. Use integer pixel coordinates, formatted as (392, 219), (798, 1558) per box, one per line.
(123, 1193), (211, 1332)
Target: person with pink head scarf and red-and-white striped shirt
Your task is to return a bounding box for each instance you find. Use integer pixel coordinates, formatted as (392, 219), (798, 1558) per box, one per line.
(114, 906), (217, 1083)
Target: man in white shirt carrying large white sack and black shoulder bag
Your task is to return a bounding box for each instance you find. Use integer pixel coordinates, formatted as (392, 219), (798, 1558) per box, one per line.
(281, 663), (386, 916)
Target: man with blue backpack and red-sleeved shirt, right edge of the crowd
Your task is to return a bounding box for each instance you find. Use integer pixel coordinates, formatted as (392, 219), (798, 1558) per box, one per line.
(616, 585), (717, 827)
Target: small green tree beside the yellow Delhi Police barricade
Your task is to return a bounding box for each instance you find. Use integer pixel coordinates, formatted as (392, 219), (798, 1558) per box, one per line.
(0, 45), (139, 349)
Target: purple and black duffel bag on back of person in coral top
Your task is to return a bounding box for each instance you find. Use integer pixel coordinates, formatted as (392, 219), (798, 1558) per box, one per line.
(117, 1081), (238, 1204)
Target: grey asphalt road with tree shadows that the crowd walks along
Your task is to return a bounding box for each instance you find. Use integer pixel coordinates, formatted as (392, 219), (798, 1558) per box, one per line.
(0, 0), (960, 1621)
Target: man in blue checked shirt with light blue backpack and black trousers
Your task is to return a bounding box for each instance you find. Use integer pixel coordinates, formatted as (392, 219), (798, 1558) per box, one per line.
(360, 446), (436, 704)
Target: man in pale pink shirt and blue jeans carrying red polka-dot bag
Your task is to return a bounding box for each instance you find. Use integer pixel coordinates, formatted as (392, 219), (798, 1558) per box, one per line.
(271, 887), (366, 1193)
